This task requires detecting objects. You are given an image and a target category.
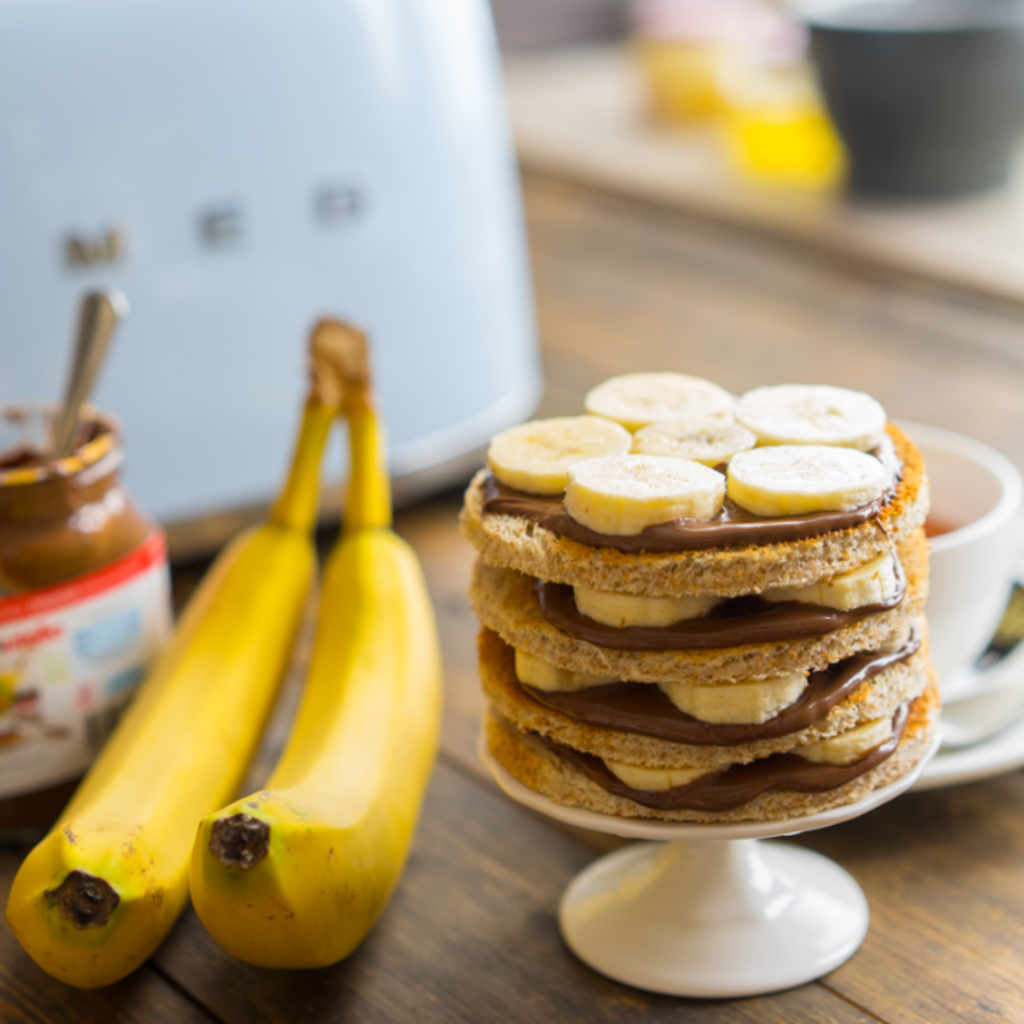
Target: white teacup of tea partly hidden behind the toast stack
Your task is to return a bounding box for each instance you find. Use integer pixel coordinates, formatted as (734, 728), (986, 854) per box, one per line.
(900, 423), (1024, 696)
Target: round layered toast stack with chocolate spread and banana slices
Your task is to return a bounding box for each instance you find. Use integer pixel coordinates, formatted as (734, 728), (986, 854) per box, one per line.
(462, 373), (938, 822)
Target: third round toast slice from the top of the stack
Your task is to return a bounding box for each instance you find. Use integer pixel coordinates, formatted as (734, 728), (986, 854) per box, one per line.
(478, 630), (929, 768)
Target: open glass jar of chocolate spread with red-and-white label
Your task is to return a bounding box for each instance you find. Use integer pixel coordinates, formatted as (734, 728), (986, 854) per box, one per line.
(0, 406), (171, 842)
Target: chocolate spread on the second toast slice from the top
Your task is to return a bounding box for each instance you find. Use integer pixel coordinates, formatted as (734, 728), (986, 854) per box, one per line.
(537, 559), (906, 650)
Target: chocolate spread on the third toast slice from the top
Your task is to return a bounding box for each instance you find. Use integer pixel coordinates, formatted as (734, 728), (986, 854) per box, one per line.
(520, 630), (921, 746)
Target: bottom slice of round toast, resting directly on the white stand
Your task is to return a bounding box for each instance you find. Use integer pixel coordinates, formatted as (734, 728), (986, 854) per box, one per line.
(484, 683), (939, 822)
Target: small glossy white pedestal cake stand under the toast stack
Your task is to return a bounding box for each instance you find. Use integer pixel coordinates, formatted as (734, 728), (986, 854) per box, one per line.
(477, 734), (938, 998)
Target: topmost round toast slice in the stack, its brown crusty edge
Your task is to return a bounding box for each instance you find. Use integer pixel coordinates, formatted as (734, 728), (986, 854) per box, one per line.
(460, 424), (929, 597)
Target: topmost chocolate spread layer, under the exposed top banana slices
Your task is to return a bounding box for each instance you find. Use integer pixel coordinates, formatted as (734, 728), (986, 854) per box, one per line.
(483, 474), (894, 554)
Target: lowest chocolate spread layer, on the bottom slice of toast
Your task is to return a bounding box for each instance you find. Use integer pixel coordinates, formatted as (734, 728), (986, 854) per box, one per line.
(535, 705), (908, 813)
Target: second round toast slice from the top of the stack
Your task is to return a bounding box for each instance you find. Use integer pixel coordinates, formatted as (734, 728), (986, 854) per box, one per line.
(470, 530), (928, 685)
